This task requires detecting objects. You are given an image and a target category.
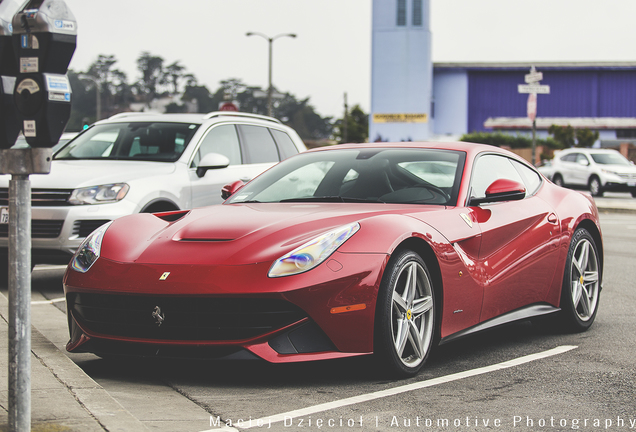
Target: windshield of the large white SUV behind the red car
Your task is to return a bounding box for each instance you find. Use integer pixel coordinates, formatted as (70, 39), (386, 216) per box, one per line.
(55, 122), (199, 162)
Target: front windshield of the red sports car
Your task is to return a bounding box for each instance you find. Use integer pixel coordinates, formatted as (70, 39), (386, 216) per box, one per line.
(228, 148), (465, 205)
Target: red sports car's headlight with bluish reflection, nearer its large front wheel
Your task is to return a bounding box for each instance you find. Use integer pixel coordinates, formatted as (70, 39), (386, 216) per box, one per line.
(267, 222), (360, 277)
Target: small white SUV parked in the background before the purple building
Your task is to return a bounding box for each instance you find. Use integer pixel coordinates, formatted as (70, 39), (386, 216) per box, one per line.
(542, 148), (636, 197)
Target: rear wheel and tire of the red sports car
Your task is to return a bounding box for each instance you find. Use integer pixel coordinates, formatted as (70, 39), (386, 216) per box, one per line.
(561, 228), (602, 332)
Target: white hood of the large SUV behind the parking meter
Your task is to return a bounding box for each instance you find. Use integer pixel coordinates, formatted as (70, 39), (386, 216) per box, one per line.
(0, 160), (175, 189)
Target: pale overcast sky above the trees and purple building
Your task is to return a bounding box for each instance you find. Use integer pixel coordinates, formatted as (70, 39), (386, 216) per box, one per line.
(66, 0), (636, 117)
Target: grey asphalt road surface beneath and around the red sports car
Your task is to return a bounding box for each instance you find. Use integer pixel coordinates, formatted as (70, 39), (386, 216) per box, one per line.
(24, 213), (636, 431)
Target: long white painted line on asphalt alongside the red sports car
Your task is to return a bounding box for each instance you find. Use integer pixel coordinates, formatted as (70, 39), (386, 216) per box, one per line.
(202, 345), (578, 432)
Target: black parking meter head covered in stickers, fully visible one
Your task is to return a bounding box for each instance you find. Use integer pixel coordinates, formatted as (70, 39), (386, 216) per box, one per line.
(12, 0), (77, 147)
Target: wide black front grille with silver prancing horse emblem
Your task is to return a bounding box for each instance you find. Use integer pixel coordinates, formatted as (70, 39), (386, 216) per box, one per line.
(66, 293), (306, 341)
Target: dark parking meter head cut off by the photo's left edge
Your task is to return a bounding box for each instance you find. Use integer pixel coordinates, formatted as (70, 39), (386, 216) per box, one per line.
(0, 0), (27, 149)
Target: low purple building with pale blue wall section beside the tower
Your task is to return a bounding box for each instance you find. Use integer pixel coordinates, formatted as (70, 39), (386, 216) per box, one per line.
(432, 62), (636, 140)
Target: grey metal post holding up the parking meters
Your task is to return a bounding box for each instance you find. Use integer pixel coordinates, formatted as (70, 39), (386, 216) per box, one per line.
(9, 174), (31, 432)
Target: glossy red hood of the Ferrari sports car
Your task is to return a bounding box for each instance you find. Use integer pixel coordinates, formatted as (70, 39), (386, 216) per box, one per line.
(102, 203), (444, 265)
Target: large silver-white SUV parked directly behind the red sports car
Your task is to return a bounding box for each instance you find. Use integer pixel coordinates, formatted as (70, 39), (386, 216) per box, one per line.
(0, 112), (306, 268)
